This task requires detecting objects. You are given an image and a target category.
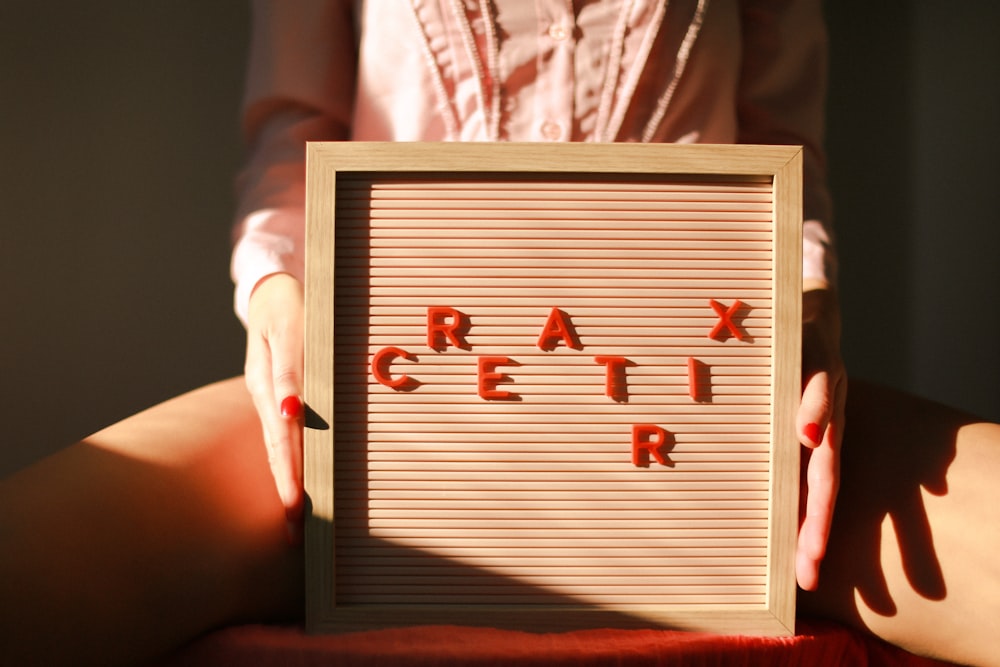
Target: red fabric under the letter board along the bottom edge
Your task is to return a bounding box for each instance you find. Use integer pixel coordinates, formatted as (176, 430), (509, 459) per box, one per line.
(163, 621), (947, 667)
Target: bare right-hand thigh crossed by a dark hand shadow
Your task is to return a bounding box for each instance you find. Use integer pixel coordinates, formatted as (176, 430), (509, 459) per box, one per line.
(800, 382), (1000, 665)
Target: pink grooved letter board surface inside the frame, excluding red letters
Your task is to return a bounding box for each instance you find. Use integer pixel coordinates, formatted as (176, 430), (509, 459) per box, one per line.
(334, 174), (774, 608)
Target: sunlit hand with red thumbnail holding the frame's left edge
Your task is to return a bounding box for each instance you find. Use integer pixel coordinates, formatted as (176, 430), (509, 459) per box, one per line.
(244, 273), (304, 543)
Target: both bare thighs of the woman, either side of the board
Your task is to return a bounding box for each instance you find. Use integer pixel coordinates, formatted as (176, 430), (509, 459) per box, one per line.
(0, 379), (1000, 665)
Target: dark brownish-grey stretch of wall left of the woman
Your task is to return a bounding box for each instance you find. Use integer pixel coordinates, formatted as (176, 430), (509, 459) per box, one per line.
(0, 5), (248, 473)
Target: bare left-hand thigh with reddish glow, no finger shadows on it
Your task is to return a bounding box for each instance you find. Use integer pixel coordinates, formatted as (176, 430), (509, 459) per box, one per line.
(0, 379), (302, 665)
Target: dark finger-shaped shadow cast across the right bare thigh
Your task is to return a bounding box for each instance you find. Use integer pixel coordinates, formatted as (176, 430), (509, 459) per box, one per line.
(799, 380), (977, 625)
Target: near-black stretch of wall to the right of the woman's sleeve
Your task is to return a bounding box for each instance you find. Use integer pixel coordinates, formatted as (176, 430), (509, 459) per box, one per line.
(827, 0), (1000, 421)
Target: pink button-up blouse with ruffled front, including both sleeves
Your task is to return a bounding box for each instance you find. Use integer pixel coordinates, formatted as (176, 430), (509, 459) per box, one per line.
(232, 0), (836, 321)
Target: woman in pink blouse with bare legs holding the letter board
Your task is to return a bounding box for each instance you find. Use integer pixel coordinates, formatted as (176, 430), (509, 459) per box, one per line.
(0, 0), (1000, 664)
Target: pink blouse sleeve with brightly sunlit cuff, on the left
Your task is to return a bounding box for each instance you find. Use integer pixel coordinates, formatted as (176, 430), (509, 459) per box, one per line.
(231, 0), (356, 323)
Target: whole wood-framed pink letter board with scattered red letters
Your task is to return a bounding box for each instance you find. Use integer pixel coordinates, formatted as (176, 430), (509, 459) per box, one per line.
(305, 143), (802, 635)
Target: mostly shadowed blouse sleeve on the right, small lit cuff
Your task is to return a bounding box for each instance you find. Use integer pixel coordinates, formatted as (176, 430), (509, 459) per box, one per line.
(737, 0), (837, 285)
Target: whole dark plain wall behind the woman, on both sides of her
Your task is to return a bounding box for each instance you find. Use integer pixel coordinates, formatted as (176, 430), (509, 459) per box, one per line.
(0, 0), (1000, 474)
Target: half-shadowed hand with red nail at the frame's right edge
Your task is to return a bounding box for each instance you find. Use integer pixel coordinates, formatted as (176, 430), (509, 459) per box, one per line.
(795, 286), (847, 590)
